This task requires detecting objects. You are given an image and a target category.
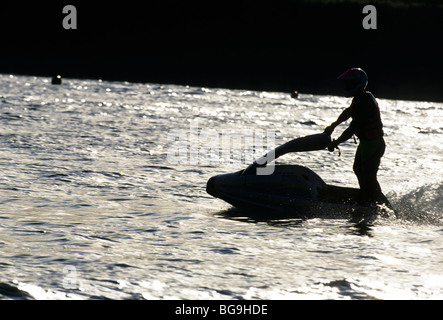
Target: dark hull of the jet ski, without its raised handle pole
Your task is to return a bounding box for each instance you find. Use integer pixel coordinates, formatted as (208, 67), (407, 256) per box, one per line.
(206, 165), (384, 217)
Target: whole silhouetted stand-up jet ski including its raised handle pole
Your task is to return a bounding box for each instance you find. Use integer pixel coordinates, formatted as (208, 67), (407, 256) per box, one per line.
(206, 133), (390, 217)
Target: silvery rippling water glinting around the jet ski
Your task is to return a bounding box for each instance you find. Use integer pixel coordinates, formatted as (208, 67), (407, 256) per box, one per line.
(0, 75), (443, 299)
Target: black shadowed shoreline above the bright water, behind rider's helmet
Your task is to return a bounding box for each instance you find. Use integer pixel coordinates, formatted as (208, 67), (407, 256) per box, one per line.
(0, 0), (443, 102)
